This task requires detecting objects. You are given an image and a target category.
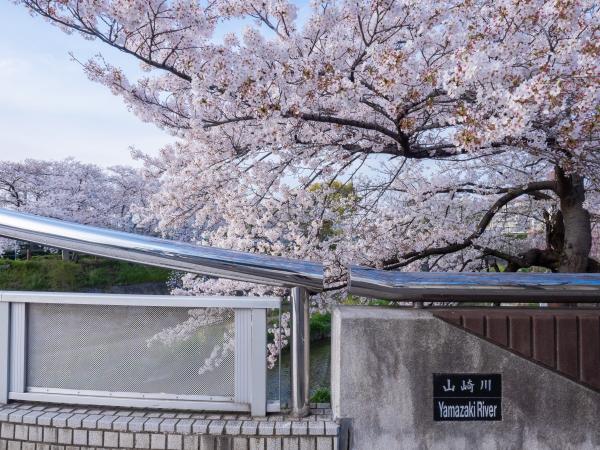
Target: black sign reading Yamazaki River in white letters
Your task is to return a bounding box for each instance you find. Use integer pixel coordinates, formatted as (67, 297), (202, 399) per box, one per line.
(433, 373), (502, 421)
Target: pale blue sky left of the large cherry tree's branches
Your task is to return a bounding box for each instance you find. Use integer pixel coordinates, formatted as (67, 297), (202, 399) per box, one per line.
(0, 0), (308, 166)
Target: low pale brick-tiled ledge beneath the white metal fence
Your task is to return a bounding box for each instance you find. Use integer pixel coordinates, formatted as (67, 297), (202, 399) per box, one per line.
(0, 403), (341, 450)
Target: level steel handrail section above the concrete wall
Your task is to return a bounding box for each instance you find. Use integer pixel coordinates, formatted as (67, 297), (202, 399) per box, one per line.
(348, 266), (600, 303)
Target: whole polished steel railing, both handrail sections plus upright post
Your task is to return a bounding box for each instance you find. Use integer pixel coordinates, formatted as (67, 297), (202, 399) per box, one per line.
(0, 209), (600, 416)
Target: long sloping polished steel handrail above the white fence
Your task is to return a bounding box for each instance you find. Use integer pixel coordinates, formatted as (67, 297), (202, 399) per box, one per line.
(0, 209), (323, 292)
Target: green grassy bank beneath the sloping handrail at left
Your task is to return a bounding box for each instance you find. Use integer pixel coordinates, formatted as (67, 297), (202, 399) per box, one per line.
(0, 255), (170, 292)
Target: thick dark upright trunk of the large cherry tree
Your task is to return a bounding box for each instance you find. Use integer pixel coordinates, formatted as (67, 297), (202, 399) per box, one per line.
(555, 167), (592, 272)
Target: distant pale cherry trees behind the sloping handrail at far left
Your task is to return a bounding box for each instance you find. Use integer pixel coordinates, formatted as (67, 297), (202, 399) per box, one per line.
(0, 159), (157, 256)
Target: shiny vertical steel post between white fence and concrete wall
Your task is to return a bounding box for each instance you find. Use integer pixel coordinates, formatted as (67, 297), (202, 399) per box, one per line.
(291, 287), (310, 417)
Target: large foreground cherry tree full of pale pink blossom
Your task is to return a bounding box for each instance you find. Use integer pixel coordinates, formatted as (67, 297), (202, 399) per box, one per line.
(11, 0), (600, 284)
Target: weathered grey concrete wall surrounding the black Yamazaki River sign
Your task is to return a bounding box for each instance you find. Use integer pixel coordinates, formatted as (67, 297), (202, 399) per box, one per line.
(332, 307), (600, 450)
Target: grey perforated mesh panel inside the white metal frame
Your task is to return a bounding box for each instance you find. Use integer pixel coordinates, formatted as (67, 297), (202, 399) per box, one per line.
(27, 304), (235, 397)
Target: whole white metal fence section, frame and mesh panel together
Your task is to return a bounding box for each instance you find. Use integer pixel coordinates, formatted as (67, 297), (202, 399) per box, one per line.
(0, 292), (280, 416)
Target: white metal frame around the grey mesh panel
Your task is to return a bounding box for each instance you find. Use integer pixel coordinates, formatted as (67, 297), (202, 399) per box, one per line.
(0, 292), (281, 416)
